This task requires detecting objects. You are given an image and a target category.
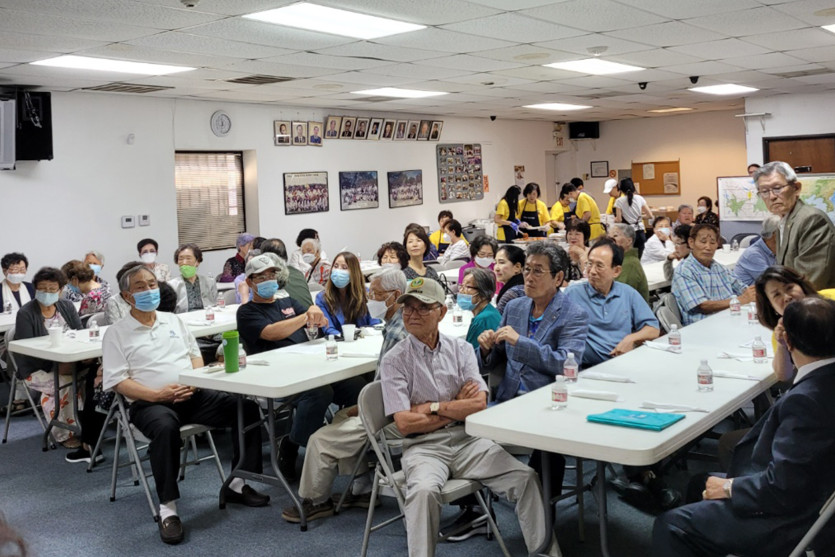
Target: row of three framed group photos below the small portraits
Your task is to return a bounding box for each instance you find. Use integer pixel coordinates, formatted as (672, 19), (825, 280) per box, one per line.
(284, 170), (423, 215)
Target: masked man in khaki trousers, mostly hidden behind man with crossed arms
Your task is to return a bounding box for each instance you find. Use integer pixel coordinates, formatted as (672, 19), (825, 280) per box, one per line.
(281, 268), (407, 523)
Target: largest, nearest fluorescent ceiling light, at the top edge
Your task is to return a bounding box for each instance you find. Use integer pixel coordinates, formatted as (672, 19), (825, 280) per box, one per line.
(243, 2), (426, 40)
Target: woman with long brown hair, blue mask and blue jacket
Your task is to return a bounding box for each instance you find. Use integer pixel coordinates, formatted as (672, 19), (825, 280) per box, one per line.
(316, 251), (380, 336)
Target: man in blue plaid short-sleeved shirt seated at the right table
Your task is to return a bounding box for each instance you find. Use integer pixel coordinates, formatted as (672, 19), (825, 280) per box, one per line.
(672, 224), (755, 326)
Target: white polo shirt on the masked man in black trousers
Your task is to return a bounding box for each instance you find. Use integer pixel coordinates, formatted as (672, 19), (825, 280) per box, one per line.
(102, 311), (200, 398)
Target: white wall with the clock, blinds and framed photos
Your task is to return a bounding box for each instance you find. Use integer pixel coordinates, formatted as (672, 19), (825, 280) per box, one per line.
(0, 93), (551, 279)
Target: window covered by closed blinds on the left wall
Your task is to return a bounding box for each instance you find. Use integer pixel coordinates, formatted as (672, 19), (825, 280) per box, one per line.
(174, 152), (246, 251)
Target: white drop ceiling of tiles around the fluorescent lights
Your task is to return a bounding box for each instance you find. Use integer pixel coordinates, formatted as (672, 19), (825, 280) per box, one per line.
(0, 0), (835, 120)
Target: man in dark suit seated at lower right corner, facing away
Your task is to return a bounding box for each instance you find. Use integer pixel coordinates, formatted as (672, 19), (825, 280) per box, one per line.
(652, 297), (835, 557)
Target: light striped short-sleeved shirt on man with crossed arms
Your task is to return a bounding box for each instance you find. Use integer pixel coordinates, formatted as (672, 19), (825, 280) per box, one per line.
(380, 334), (487, 416)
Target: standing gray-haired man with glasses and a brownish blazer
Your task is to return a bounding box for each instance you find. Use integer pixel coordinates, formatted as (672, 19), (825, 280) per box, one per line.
(753, 161), (835, 290)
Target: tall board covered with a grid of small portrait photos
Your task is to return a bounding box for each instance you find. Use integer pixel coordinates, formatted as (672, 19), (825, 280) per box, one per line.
(435, 143), (484, 203)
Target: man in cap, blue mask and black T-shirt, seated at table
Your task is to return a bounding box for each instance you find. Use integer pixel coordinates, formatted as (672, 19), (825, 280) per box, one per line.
(237, 253), (365, 481)
